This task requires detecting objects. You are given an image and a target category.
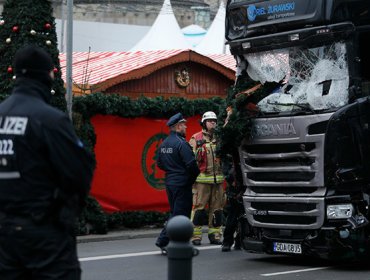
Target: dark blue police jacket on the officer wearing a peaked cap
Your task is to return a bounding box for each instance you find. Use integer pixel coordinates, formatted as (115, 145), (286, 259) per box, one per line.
(157, 131), (199, 187)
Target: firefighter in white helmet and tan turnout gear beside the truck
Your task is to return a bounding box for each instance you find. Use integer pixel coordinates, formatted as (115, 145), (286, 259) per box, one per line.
(189, 111), (224, 245)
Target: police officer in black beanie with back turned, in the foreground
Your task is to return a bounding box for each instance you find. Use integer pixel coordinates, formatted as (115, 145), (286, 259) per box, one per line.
(0, 46), (94, 280)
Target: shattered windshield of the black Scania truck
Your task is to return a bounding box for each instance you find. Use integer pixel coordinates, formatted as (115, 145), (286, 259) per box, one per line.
(245, 43), (349, 112)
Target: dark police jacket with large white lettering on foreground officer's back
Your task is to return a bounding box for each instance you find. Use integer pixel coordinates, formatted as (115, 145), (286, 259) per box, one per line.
(0, 78), (94, 220)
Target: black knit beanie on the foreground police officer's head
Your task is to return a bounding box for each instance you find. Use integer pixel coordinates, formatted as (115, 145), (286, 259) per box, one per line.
(13, 45), (54, 88)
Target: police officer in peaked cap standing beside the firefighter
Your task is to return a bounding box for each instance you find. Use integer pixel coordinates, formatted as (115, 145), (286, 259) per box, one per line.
(155, 113), (199, 250)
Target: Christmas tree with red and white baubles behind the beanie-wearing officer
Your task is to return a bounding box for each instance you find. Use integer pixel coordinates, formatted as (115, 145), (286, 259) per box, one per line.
(0, 0), (66, 110)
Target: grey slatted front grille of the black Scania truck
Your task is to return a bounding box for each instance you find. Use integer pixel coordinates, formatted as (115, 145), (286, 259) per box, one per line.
(239, 114), (331, 229)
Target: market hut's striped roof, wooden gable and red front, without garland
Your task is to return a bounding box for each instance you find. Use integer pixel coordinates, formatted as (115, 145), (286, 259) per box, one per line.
(60, 50), (235, 212)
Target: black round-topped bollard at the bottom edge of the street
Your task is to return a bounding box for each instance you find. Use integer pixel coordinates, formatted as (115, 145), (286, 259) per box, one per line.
(166, 215), (199, 280)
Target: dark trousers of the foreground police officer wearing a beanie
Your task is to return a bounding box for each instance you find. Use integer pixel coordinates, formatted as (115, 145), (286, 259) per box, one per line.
(0, 218), (81, 280)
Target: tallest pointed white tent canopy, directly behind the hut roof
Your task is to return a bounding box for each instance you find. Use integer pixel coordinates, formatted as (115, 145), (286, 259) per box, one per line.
(130, 0), (190, 51)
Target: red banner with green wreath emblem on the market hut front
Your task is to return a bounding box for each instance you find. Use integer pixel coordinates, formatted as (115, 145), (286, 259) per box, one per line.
(91, 115), (201, 212)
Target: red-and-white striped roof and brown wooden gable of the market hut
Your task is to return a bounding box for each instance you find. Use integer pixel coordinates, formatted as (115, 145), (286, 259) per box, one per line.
(60, 50), (235, 99)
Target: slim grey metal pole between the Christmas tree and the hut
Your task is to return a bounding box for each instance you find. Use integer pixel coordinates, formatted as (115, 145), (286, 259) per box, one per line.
(66, 0), (73, 120)
